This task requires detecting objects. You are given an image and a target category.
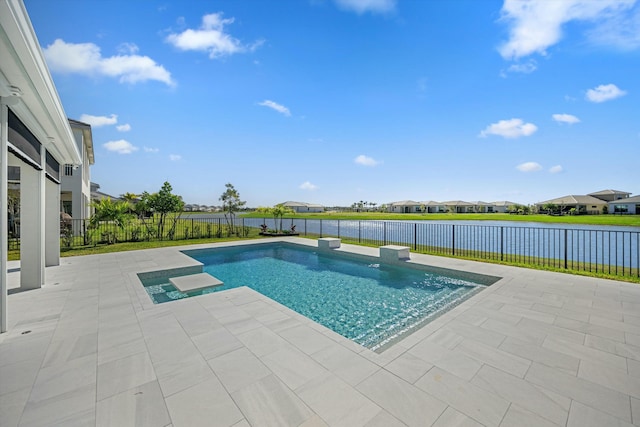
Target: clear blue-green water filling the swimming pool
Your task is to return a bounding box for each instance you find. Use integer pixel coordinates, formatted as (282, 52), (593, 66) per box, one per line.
(144, 244), (497, 350)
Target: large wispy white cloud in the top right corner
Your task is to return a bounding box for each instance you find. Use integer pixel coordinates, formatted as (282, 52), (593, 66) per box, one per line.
(498, 0), (635, 59)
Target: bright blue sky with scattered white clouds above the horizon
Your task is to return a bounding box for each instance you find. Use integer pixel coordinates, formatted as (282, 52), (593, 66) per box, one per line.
(25, 0), (640, 207)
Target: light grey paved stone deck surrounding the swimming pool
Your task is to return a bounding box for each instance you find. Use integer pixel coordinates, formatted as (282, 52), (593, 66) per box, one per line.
(0, 237), (640, 427)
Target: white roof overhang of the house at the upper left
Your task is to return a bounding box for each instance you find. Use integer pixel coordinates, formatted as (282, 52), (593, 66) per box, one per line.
(0, 0), (82, 165)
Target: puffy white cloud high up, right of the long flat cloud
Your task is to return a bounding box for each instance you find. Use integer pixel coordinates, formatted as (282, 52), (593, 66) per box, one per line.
(166, 12), (264, 59)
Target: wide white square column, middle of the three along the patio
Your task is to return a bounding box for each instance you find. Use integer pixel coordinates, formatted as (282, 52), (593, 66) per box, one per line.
(20, 147), (46, 289)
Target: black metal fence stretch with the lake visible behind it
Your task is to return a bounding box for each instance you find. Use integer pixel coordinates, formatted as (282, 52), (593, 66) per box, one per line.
(245, 218), (640, 278)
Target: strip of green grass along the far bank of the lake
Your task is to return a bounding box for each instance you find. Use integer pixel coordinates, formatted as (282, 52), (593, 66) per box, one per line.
(241, 212), (640, 227)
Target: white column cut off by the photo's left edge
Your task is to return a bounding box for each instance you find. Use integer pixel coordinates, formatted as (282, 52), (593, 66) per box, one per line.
(0, 98), (9, 333)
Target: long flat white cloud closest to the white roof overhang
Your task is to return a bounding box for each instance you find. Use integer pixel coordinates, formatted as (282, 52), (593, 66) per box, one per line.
(44, 39), (175, 86)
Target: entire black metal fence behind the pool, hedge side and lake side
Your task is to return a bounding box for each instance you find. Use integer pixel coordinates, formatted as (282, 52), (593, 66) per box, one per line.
(9, 217), (640, 278)
